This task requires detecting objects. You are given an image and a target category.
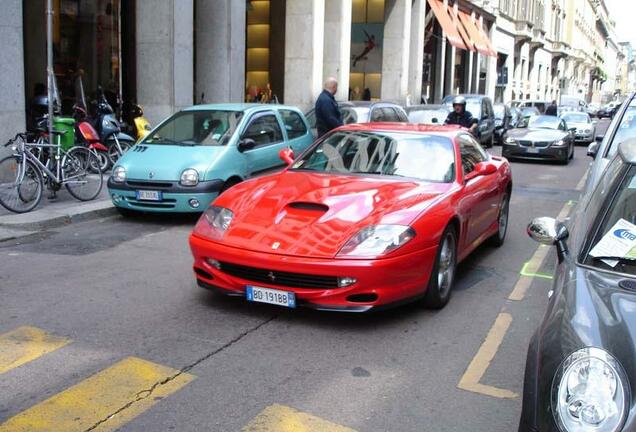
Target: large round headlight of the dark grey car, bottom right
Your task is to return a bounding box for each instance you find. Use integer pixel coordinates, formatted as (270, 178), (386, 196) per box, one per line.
(552, 348), (629, 432)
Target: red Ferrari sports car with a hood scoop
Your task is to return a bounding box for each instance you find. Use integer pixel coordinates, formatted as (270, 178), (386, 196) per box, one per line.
(190, 123), (512, 312)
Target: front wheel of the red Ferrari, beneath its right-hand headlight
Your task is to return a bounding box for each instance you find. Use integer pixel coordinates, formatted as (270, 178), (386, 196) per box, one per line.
(424, 226), (457, 309)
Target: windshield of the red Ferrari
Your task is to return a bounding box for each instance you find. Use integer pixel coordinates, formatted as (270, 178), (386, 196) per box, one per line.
(292, 131), (455, 183)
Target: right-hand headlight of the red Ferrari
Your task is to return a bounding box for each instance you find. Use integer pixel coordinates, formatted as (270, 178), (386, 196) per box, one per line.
(338, 225), (415, 258)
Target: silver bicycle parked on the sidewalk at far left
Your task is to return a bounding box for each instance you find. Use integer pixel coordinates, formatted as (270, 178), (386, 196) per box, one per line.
(0, 131), (104, 213)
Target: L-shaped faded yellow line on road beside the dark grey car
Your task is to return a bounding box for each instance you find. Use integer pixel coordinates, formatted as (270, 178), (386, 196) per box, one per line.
(457, 313), (518, 399)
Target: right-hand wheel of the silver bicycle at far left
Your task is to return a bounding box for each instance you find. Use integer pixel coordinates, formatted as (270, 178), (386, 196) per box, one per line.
(62, 147), (104, 201)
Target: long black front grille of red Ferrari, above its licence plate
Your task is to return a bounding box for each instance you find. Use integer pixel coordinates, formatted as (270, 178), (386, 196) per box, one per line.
(221, 262), (338, 289)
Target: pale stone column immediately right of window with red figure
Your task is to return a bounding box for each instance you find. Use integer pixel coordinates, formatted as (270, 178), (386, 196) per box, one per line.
(381, 0), (412, 101)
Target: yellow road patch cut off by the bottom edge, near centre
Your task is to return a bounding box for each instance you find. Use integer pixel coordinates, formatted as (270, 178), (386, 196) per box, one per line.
(241, 404), (355, 432)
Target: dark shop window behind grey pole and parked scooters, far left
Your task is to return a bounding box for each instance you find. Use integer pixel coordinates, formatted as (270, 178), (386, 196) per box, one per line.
(23, 0), (124, 114)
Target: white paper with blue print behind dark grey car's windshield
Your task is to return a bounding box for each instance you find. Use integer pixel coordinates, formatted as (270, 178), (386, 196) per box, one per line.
(590, 219), (636, 267)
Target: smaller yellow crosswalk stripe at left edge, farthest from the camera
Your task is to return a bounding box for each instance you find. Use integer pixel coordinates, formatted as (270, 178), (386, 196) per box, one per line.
(0, 326), (71, 374)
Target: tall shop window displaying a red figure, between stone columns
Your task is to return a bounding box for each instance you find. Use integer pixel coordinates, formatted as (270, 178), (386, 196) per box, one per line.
(349, 0), (384, 100)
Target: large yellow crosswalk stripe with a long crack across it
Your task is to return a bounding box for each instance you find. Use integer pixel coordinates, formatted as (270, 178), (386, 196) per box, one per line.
(0, 357), (195, 432)
